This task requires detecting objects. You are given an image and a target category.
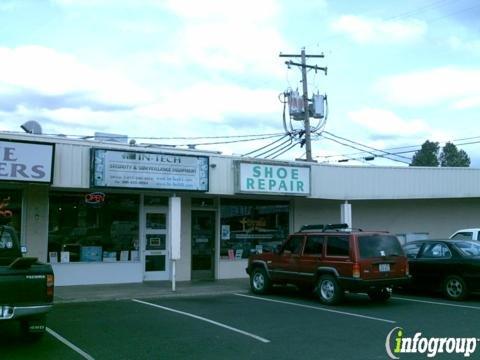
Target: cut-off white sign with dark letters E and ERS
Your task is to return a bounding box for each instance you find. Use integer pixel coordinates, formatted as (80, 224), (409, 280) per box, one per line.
(0, 141), (54, 183)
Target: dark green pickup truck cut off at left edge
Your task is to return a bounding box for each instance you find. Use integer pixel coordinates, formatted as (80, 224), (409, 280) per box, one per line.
(0, 225), (54, 339)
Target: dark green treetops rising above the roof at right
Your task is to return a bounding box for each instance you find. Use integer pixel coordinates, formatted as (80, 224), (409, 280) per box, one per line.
(410, 140), (470, 167)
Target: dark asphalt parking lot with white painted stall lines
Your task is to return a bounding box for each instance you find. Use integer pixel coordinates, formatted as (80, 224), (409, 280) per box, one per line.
(0, 289), (480, 359)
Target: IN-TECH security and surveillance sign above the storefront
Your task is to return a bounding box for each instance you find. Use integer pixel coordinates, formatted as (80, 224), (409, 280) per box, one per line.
(91, 149), (208, 191)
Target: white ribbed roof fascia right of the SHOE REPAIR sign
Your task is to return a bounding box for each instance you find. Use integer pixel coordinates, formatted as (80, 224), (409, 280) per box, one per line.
(312, 165), (480, 200)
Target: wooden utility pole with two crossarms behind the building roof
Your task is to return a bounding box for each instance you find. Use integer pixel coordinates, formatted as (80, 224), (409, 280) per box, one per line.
(279, 48), (327, 162)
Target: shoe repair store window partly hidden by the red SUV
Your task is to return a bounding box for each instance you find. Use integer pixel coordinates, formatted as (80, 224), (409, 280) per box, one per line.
(220, 199), (289, 260)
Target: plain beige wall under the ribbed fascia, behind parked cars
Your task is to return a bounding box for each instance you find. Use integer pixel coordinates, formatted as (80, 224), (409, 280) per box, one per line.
(294, 198), (480, 239)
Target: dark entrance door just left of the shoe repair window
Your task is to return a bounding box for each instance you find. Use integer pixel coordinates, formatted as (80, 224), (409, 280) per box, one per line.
(192, 210), (216, 280)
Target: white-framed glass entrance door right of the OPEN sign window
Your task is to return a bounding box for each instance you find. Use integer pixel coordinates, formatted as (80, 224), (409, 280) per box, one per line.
(143, 209), (170, 281)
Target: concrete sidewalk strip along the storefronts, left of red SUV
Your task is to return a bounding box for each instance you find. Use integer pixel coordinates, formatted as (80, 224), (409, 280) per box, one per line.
(54, 278), (250, 304)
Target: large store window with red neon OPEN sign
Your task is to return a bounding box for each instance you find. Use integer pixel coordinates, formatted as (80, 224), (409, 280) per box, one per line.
(48, 193), (140, 263)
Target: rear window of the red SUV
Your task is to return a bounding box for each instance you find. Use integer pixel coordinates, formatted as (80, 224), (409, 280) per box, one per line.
(358, 235), (404, 259)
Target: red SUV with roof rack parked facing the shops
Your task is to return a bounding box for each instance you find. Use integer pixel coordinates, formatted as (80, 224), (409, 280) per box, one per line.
(246, 224), (410, 305)
